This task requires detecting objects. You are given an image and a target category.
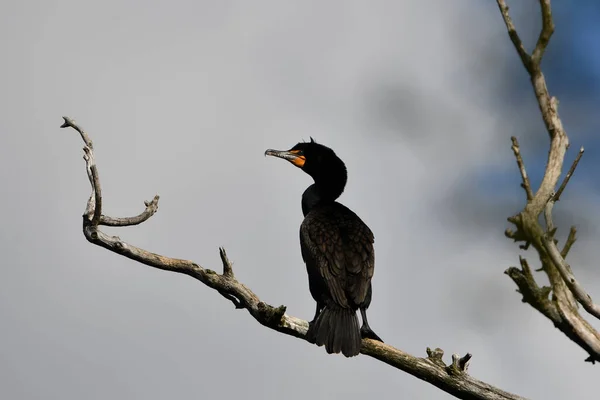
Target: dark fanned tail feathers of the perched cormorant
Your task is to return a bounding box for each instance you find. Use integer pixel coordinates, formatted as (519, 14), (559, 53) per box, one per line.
(308, 305), (361, 357)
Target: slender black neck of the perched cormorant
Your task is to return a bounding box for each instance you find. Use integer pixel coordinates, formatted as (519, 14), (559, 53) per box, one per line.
(302, 164), (348, 216)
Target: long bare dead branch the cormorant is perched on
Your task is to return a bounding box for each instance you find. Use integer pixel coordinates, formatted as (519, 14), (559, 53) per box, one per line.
(61, 117), (525, 400)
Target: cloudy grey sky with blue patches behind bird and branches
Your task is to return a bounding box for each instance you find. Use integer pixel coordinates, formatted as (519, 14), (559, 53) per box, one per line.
(0, 0), (600, 400)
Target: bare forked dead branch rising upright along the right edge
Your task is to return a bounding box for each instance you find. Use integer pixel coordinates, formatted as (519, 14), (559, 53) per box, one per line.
(496, 0), (600, 363)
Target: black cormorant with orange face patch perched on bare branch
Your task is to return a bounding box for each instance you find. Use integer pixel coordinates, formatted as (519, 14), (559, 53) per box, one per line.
(265, 138), (382, 357)
